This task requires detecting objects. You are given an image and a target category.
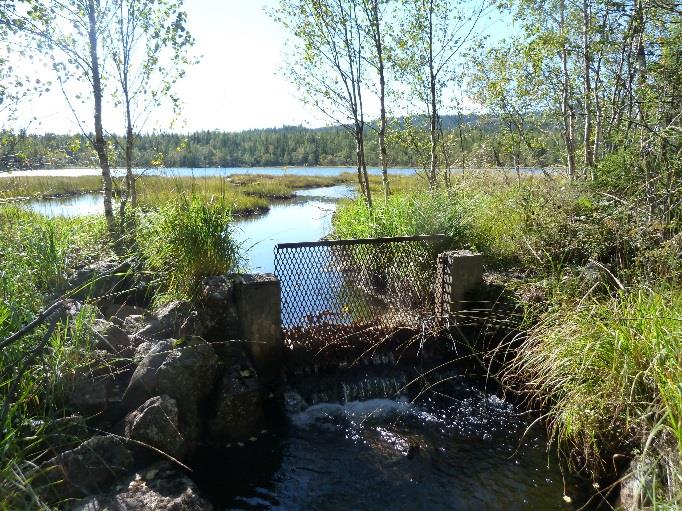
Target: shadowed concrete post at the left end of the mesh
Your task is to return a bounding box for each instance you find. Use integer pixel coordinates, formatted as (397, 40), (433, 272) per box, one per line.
(235, 273), (282, 387)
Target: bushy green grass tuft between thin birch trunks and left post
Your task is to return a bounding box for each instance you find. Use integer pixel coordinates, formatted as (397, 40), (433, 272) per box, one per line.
(137, 196), (239, 303)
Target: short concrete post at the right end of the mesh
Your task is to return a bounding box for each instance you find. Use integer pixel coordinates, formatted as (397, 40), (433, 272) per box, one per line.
(435, 250), (483, 317)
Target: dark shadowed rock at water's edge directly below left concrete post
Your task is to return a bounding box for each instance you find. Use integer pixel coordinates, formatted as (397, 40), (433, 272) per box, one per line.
(208, 360), (264, 446)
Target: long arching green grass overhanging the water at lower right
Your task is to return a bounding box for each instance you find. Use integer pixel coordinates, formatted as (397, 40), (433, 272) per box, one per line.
(506, 288), (682, 504)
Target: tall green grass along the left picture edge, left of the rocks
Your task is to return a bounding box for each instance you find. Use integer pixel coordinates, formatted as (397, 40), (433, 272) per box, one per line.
(0, 206), (106, 509)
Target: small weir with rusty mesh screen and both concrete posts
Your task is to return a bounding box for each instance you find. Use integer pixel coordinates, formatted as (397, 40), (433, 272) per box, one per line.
(228, 236), (482, 404)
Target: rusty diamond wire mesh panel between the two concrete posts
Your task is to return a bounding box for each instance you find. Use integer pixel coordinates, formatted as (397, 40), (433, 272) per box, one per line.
(275, 236), (446, 348)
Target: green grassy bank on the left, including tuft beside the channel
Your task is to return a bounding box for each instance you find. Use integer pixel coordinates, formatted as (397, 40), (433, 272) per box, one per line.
(0, 195), (239, 510)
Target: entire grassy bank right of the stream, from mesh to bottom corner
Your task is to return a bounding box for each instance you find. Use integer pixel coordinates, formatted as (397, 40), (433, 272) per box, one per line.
(333, 169), (682, 508)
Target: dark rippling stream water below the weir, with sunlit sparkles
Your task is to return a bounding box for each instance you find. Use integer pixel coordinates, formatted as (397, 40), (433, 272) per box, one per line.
(198, 377), (573, 511)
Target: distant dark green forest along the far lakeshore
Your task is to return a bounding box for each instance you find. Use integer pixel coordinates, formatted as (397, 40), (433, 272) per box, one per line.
(0, 115), (563, 170)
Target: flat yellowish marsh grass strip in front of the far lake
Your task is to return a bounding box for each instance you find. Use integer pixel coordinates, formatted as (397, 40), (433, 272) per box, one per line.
(0, 173), (355, 214)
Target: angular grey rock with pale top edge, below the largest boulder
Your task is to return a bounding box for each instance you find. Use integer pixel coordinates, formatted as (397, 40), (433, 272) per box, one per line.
(125, 395), (185, 459)
